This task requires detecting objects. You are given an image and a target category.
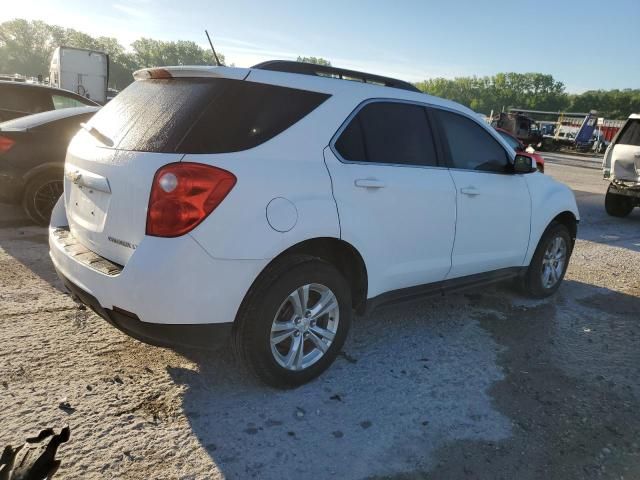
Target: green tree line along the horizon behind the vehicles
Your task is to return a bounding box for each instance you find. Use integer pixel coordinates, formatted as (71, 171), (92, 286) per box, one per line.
(0, 19), (640, 119)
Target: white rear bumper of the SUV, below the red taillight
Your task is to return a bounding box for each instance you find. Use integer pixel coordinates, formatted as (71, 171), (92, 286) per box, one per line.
(49, 199), (268, 330)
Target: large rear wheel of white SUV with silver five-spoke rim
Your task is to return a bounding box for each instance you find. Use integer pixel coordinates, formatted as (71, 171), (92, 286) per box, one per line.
(235, 255), (352, 388)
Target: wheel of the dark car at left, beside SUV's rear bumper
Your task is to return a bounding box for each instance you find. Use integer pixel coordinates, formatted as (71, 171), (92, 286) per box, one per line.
(22, 171), (63, 226)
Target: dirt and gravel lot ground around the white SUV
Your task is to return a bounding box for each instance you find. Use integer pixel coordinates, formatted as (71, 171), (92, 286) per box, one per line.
(0, 164), (640, 479)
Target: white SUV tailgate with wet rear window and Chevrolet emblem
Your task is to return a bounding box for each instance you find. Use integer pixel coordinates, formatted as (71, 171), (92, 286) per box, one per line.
(64, 80), (221, 265)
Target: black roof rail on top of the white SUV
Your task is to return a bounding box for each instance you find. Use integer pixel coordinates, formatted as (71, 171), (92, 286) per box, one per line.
(251, 60), (421, 93)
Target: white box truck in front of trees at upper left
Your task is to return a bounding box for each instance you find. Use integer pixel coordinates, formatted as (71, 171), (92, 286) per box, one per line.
(49, 47), (109, 105)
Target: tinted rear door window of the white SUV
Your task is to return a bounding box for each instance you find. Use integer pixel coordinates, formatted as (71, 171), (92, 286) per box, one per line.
(335, 102), (438, 166)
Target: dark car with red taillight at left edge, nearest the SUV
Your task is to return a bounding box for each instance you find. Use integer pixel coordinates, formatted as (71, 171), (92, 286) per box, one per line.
(0, 107), (99, 225)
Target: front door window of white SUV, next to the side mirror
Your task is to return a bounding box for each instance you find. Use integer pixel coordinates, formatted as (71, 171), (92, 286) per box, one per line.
(434, 110), (509, 173)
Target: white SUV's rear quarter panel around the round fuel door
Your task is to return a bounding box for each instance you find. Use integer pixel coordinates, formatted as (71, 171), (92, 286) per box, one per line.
(183, 98), (357, 260)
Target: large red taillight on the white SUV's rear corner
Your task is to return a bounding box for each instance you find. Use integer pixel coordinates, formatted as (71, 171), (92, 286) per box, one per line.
(147, 163), (236, 237)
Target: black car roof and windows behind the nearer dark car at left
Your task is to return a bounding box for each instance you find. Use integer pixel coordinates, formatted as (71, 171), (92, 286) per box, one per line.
(0, 81), (98, 122)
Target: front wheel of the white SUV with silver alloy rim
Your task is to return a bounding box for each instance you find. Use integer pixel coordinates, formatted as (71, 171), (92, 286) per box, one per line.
(523, 223), (573, 298)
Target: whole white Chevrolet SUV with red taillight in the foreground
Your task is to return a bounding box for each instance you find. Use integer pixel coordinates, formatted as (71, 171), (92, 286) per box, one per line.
(49, 61), (578, 387)
